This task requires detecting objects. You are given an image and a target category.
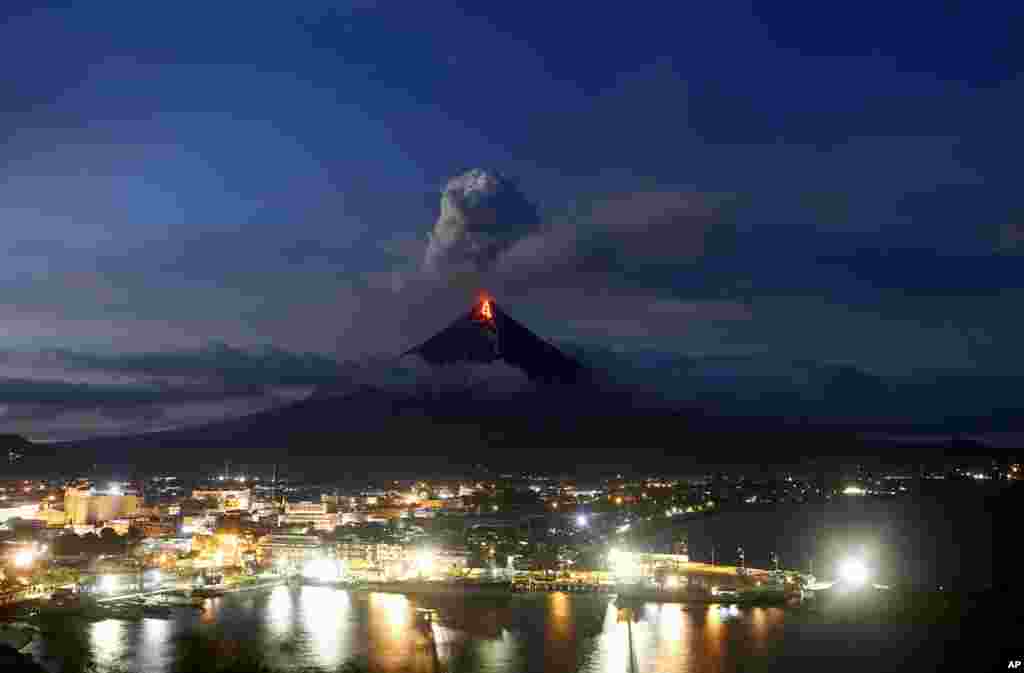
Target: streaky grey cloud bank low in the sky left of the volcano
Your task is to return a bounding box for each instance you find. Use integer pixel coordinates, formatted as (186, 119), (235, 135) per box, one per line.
(0, 345), (342, 439)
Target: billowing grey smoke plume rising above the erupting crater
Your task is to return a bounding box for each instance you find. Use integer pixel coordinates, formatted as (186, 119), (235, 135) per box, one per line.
(424, 168), (541, 274)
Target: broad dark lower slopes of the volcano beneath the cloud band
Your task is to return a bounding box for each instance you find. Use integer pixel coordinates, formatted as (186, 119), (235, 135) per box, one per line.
(65, 385), (1011, 470)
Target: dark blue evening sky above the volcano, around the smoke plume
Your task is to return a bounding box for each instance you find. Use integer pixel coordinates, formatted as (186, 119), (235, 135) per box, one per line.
(0, 1), (1024, 440)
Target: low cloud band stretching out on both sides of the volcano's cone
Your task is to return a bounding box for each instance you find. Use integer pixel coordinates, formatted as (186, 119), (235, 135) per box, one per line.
(0, 341), (1019, 440)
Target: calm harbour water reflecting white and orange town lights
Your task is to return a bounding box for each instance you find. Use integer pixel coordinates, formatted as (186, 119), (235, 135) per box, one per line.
(24, 586), (954, 673)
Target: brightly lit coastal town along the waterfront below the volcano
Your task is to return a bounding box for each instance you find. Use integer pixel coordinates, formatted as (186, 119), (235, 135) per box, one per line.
(0, 463), (1022, 605)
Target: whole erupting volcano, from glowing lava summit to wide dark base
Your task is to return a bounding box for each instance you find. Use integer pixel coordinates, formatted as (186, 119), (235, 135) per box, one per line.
(50, 296), (974, 472)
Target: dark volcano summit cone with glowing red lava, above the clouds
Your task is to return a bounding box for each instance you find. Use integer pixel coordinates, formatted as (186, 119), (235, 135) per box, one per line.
(402, 296), (587, 383)
